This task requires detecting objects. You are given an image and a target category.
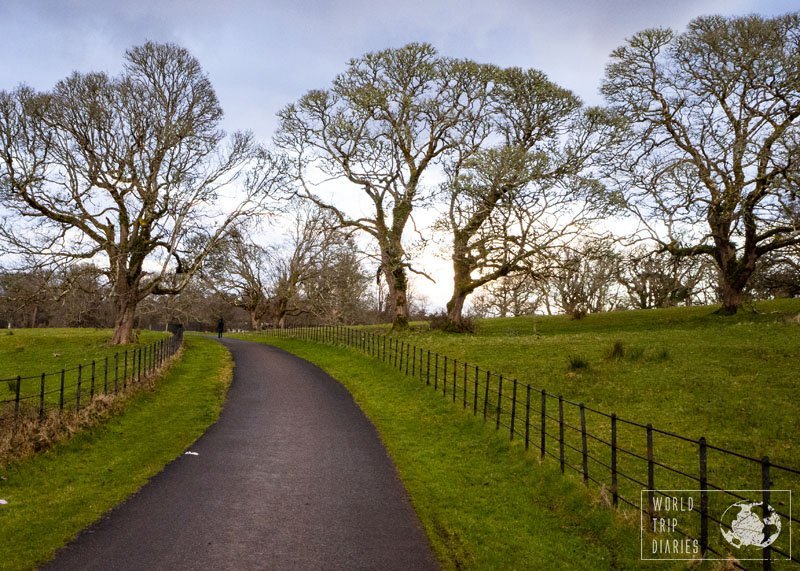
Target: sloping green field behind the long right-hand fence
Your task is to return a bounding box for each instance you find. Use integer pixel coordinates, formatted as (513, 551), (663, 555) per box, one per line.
(368, 299), (800, 466)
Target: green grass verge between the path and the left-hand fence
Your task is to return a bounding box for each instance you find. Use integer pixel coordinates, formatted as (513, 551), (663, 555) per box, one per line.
(0, 336), (232, 569)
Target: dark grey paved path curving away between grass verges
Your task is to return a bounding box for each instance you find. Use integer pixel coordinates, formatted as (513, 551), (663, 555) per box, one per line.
(47, 339), (436, 570)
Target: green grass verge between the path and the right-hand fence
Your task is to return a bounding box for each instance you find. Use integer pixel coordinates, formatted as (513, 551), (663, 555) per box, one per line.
(242, 338), (669, 569)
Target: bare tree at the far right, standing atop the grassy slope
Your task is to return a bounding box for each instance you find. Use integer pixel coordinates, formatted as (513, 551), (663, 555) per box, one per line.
(602, 13), (800, 314)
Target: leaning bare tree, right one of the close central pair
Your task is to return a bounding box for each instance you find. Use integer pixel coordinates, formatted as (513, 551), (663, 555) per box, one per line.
(442, 68), (614, 327)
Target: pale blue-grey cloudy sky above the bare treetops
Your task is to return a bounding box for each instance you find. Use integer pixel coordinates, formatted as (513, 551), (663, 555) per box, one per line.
(0, 0), (800, 310)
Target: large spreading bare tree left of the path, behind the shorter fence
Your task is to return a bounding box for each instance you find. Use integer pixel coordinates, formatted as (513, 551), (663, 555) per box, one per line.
(0, 43), (281, 343)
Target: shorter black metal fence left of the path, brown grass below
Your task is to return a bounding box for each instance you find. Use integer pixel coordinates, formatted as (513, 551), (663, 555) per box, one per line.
(0, 332), (183, 426)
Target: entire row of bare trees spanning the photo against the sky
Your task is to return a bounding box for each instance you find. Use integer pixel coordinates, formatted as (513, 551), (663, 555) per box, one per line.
(0, 13), (800, 342)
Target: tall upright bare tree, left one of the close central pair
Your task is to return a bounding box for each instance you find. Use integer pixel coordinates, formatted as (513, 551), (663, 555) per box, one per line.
(277, 44), (494, 327)
